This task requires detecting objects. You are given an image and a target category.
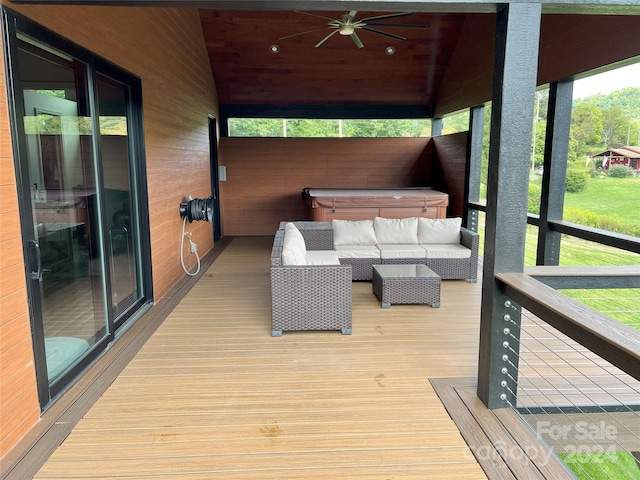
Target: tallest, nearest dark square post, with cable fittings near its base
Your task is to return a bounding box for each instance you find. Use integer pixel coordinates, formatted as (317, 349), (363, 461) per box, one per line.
(478, 3), (541, 408)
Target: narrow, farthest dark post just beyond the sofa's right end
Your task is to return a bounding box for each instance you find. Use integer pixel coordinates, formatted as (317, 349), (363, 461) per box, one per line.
(463, 105), (484, 232)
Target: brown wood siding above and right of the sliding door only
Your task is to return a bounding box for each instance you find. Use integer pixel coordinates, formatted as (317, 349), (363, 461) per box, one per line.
(3, 5), (218, 298)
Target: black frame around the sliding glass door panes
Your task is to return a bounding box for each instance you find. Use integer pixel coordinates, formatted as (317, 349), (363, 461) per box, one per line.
(0, 5), (153, 406)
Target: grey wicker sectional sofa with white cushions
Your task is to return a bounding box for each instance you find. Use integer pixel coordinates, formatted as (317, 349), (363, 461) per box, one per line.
(271, 217), (479, 336)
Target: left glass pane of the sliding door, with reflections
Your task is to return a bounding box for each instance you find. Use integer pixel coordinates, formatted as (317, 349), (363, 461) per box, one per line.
(18, 42), (109, 386)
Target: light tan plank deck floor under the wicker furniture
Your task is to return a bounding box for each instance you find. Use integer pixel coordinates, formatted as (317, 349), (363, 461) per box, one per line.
(35, 238), (486, 480)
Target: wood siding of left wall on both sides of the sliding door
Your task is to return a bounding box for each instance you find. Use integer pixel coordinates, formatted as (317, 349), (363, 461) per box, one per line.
(0, 0), (218, 456)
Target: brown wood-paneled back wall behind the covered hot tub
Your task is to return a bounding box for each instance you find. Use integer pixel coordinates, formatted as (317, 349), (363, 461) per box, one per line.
(220, 137), (430, 235)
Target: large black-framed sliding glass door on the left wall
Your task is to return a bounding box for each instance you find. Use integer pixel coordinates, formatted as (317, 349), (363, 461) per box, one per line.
(5, 7), (151, 408)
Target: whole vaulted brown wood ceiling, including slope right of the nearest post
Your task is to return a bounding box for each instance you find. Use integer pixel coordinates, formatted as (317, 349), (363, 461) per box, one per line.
(199, 7), (640, 116)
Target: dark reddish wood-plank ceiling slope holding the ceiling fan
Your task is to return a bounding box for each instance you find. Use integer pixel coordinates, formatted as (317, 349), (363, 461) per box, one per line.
(199, 9), (467, 109)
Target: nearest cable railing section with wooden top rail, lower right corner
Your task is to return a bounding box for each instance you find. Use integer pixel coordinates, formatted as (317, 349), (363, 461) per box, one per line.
(499, 282), (640, 480)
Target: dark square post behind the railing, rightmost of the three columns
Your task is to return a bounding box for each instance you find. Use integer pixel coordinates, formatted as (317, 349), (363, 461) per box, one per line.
(536, 80), (573, 265)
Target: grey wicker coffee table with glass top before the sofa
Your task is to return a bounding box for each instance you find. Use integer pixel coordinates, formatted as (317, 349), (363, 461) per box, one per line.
(372, 265), (440, 308)
